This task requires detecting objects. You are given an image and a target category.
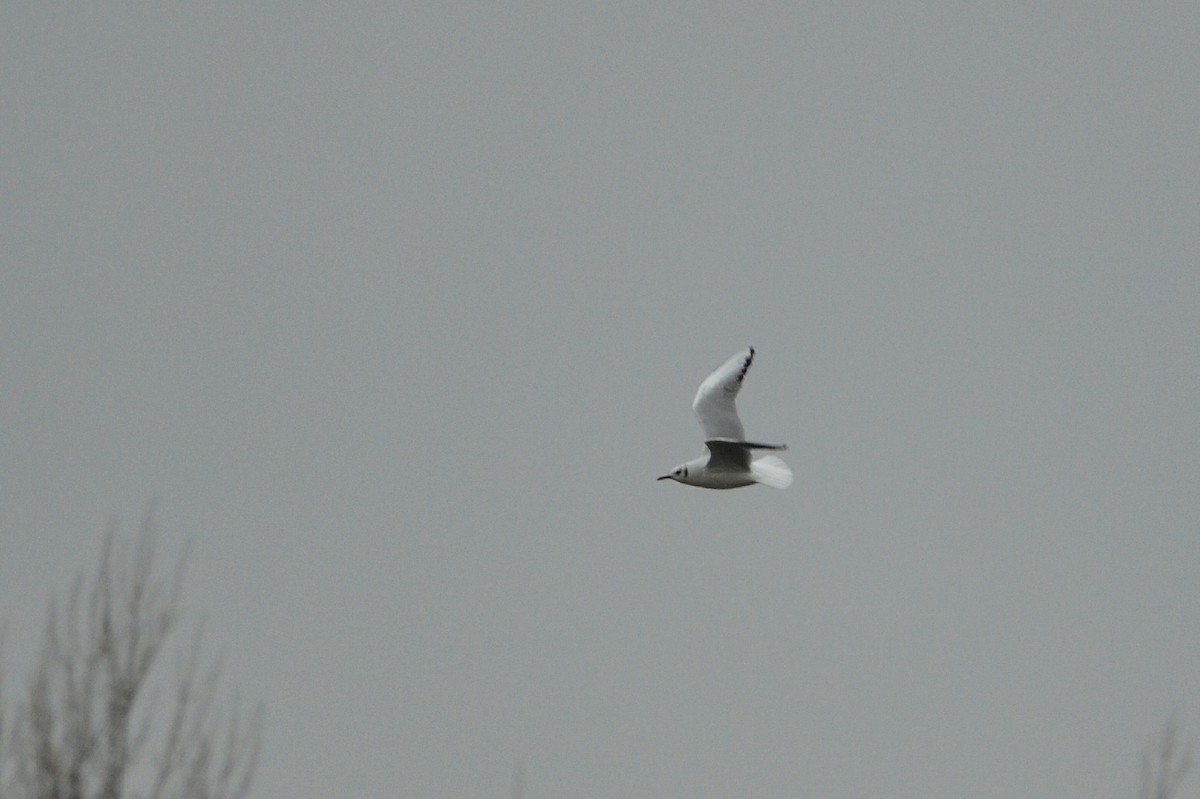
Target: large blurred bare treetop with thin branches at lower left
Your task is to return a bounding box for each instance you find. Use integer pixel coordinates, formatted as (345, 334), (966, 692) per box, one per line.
(0, 512), (262, 799)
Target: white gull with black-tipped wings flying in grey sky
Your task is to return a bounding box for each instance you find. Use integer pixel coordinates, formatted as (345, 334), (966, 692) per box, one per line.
(659, 347), (792, 488)
